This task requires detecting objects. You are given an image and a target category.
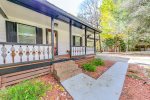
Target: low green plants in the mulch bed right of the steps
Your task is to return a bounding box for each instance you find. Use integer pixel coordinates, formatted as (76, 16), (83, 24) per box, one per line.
(83, 59), (104, 72)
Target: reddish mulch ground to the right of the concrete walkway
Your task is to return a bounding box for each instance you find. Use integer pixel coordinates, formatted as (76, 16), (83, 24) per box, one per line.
(120, 65), (150, 100)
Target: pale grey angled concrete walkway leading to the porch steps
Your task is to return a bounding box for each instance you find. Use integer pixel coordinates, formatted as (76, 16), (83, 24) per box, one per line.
(61, 62), (128, 100)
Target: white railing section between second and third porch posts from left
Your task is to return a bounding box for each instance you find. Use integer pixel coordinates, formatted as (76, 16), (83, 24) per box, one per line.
(71, 46), (85, 56)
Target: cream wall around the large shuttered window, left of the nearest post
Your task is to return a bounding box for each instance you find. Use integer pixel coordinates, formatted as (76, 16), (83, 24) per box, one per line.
(0, 0), (51, 44)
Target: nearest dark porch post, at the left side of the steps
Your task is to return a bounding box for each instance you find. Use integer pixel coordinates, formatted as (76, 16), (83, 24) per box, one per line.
(51, 17), (55, 60)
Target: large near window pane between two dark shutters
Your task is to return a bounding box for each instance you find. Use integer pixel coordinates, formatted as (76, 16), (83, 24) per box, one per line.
(17, 24), (36, 44)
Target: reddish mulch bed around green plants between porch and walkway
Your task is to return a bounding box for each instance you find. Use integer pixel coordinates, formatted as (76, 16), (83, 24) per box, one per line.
(81, 60), (115, 79)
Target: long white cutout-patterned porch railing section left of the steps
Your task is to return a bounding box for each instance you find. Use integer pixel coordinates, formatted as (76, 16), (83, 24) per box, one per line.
(0, 43), (52, 65)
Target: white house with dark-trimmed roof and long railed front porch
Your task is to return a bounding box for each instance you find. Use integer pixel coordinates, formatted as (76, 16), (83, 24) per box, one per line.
(0, 0), (101, 85)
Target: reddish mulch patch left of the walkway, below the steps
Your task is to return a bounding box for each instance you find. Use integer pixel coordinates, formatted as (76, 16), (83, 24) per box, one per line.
(39, 74), (73, 100)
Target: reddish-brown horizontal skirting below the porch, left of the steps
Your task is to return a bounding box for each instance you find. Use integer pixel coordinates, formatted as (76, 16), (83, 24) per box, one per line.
(0, 66), (51, 87)
